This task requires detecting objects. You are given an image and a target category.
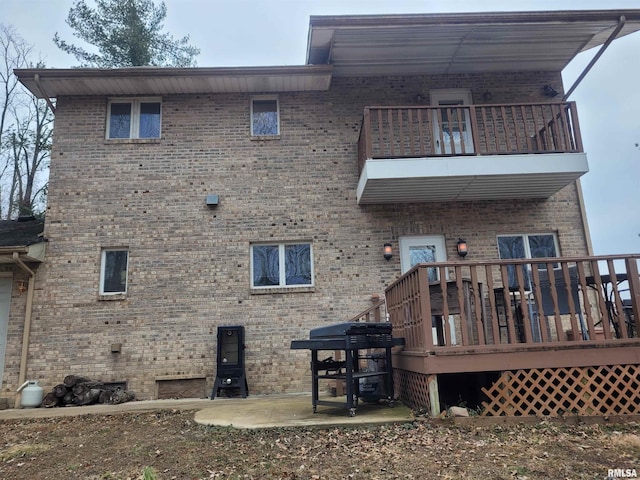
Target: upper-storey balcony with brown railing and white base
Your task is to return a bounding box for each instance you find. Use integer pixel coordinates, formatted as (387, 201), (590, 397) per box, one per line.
(357, 102), (588, 204)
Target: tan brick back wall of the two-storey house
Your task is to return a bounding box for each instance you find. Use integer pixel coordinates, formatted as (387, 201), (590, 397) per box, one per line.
(5, 73), (586, 398)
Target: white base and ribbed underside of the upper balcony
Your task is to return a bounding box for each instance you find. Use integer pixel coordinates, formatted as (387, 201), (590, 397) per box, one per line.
(357, 153), (589, 204)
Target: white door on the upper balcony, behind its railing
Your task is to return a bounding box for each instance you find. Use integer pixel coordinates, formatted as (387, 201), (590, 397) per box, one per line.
(429, 89), (474, 155)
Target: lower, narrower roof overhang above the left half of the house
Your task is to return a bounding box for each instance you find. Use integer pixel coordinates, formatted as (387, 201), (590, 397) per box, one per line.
(15, 65), (333, 98)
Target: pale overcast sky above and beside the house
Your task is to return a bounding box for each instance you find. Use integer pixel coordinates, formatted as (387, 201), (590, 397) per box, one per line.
(0, 0), (640, 255)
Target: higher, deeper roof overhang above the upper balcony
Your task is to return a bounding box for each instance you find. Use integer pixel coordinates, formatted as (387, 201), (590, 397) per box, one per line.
(307, 9), (640, 77)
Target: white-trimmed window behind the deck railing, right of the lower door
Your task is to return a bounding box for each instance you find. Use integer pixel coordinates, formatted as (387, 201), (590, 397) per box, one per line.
(498, 233), (558, 290)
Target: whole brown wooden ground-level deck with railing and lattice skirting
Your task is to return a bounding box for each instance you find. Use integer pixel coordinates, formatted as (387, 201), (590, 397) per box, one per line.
(353, 255), (640, 415)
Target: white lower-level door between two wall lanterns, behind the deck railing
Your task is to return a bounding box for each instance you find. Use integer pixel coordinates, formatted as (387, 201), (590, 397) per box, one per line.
(399, 235), (456, 345)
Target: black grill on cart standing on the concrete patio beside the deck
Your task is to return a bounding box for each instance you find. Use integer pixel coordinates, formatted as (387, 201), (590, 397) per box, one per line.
(291, 322), (404, 417)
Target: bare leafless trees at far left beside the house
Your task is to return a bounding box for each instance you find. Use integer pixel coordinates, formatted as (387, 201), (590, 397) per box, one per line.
(0, 24), (53, 218)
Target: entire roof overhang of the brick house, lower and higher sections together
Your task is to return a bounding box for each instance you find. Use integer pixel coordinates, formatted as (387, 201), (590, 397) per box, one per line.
(15, 9), (640, 98)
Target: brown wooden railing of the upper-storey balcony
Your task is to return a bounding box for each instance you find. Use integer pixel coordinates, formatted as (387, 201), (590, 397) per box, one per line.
(359, 102), (583, 171)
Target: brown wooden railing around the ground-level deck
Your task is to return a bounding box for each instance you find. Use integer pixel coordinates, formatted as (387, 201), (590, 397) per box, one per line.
(386, 255), (640, 354)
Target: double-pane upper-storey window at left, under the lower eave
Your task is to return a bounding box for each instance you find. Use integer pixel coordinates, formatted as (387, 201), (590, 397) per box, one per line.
(107, 98), (162, 138)
